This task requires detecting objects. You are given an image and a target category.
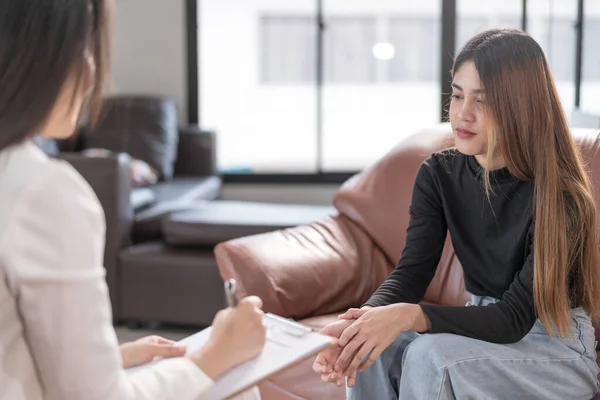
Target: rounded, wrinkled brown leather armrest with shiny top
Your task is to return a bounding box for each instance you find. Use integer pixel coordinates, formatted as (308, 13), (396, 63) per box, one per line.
(215, 216), (391, 319)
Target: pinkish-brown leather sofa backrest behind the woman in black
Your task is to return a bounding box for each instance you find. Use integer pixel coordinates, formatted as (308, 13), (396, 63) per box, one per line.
(334, 124), (600, 305)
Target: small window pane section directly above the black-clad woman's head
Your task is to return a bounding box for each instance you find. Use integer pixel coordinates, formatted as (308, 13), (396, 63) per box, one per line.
(456, 0), (523, 49)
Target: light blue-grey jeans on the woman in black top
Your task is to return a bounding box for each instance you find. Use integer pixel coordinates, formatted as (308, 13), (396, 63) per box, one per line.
(347, 296), (599, 400)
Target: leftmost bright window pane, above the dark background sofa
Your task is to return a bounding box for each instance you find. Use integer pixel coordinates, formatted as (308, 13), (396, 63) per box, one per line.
(199, 0), (317, 173)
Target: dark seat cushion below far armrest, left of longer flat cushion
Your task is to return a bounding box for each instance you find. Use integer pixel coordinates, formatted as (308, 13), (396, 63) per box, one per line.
(133, 176), (222, 242)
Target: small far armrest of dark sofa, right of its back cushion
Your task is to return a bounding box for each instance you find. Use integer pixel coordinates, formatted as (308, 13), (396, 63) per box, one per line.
(175, 125), (217, 176)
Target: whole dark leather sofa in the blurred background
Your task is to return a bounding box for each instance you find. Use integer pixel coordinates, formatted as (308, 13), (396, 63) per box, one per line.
(36, 96), (335, 327)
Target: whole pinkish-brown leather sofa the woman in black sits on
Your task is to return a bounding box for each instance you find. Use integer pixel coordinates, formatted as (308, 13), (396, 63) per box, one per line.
(215, 124), (600, 400)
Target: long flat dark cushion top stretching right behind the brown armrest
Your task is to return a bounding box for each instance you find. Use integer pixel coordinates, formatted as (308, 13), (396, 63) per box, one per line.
(162, 201), (337, 246)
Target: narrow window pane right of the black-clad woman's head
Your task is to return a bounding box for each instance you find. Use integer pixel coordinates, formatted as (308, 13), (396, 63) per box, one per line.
(527, 0), (577, 118)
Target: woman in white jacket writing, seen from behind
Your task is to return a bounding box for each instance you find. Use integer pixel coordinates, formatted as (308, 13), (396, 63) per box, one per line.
(0, 0), (266, 400)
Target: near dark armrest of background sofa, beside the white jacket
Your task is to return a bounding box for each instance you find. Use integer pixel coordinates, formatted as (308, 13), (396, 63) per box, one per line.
(57, 153), (133, 318)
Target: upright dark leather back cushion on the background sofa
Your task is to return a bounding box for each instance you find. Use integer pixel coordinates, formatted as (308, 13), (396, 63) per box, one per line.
(83, 97), (179, 179)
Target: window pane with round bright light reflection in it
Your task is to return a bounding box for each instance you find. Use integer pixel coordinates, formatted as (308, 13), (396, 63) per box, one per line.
(322, 0), (442, 171)
